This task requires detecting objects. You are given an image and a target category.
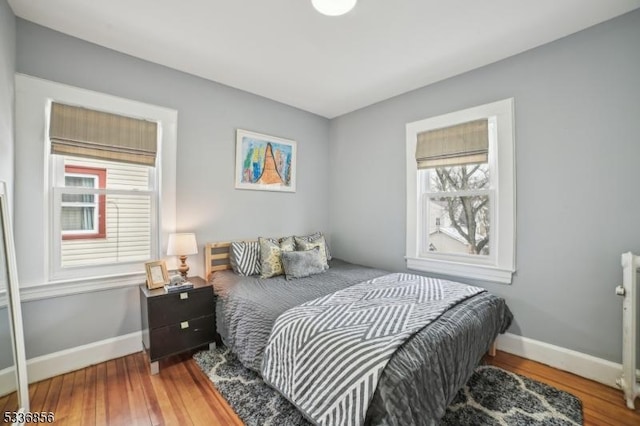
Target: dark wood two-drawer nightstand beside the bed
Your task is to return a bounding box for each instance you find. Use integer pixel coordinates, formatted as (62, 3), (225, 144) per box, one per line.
(140, 277), (217, 374)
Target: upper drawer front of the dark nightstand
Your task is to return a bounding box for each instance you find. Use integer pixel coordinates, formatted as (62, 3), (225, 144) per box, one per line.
(148, 286), (215, 329)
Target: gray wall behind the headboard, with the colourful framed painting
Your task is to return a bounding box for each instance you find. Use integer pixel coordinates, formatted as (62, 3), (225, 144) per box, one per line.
(16, 19), (329, 358)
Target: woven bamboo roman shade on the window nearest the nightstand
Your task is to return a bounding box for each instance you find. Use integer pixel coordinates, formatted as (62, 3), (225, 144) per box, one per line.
(49, 102), (158, 166)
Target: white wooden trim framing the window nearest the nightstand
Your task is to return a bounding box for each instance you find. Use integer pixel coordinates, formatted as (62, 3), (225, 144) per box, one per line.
(15, 73), (178, 287)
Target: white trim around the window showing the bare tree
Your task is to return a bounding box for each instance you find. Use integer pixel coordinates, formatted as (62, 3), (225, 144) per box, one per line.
(405, 98), (516, 284)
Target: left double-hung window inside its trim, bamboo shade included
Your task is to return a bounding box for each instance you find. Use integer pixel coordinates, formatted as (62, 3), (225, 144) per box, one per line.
(49, 102), (158, 278)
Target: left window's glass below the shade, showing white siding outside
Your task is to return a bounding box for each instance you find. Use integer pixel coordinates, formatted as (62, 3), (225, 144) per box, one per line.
(51, 154), (156, 269)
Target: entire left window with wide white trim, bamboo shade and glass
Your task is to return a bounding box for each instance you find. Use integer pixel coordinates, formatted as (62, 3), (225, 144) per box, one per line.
(14, 74), (178, 300)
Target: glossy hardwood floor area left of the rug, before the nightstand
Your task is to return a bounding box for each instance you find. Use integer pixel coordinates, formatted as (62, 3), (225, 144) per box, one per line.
(0, 352), (242, 426)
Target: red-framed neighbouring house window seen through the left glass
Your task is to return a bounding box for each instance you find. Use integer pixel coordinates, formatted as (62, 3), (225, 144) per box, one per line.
(60, 165), (107, 240)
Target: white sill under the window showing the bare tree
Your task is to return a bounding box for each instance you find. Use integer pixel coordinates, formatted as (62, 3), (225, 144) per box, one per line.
(406, 257), (515, 284)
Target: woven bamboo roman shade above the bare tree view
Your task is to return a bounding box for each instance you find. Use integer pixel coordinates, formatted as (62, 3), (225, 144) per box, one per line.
(416, 119), (489, 169)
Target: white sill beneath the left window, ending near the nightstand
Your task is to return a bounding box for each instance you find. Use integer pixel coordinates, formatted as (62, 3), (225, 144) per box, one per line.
(20, 274), (146, 302)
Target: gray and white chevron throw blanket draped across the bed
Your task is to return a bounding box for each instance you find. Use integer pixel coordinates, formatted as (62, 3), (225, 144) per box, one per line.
(262, 273), (485, 425)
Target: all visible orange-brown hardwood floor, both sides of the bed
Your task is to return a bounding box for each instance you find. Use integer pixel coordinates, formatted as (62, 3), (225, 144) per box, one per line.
(0, 351), (640, 426)
